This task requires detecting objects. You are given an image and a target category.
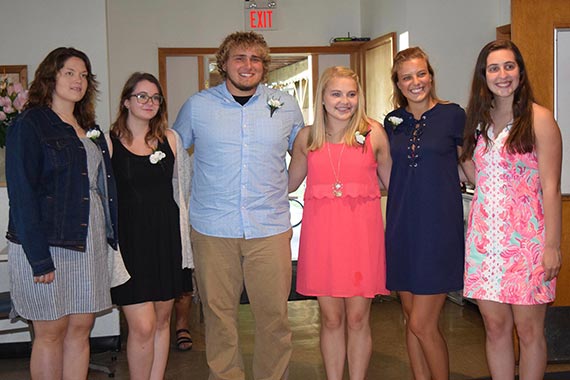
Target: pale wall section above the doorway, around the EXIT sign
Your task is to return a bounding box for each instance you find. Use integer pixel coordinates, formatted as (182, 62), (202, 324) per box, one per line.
(107, 0), (360, 118)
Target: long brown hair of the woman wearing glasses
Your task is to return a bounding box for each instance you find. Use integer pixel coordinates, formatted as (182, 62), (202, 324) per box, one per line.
(111, 72), (168, 148)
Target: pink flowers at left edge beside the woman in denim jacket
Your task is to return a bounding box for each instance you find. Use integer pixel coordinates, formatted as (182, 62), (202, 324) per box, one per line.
(0, 76), (28, 148)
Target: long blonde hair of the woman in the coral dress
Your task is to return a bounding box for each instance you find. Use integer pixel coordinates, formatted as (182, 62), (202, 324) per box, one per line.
(307, 66), (370, 150)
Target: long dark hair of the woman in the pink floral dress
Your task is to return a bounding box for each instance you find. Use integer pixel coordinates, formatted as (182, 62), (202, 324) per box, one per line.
(461, 40), (535, 161)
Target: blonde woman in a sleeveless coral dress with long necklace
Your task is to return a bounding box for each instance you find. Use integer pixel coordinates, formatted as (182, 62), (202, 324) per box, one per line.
(289, 67), (391, 380)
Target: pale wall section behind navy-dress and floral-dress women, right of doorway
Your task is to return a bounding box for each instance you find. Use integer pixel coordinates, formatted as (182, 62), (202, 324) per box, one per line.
(361, 0), (510, 107)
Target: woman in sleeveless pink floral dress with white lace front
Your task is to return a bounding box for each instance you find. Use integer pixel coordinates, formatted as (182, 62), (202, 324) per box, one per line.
(462, 41), (562, 379)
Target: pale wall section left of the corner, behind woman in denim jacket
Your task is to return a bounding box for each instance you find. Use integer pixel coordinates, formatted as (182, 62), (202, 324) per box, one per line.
(0, 0), (110, 248)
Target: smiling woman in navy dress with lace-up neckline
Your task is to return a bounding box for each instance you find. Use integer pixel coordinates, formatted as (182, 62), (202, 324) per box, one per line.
(384, 47), (465, 380)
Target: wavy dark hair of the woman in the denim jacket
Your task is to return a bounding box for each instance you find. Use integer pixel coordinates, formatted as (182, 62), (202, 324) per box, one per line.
(26, 47), (99, 130)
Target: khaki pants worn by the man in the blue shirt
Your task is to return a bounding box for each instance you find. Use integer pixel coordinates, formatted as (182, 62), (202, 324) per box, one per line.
(191, 230), (293, 380)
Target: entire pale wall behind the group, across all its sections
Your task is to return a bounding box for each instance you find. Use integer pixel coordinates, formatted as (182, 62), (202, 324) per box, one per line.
(0, 0), (510, 247)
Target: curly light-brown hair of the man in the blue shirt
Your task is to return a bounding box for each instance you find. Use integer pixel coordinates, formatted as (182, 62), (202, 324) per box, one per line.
(216, 32), (271, 81)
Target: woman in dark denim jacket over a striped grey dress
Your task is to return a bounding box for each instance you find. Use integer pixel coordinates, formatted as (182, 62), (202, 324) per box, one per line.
(6, 48), (117, 379)
